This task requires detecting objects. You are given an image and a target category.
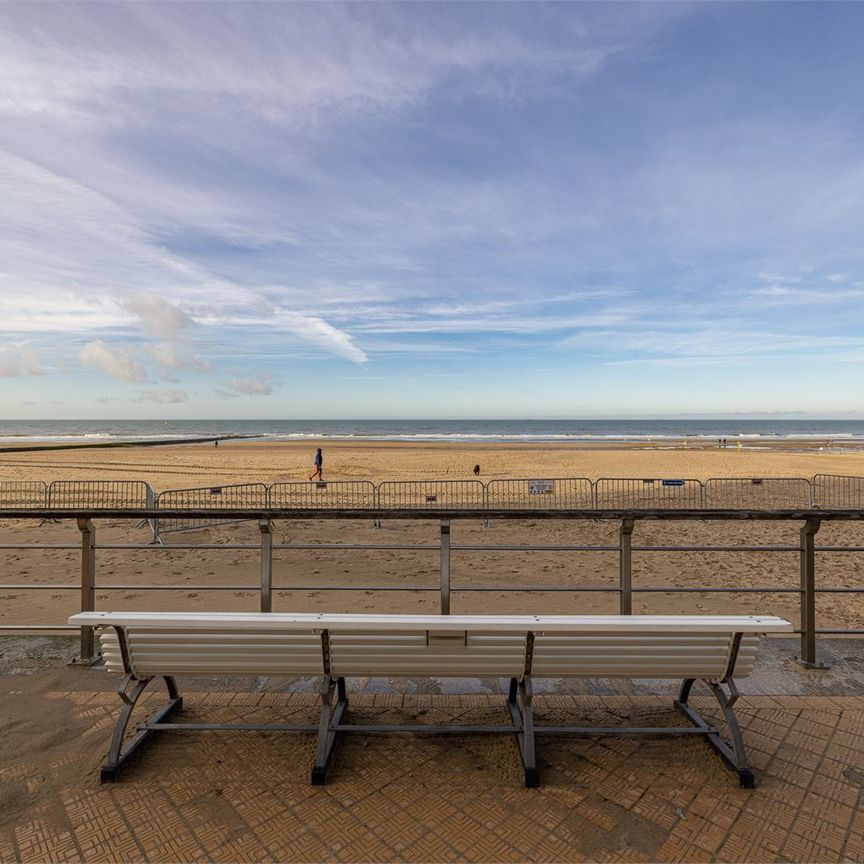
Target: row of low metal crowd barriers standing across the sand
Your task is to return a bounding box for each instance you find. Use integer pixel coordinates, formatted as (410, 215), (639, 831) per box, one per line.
(0, 474), (864, 512)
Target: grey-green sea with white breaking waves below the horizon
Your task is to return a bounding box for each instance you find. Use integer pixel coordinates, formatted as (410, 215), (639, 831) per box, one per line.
(0, 418), (864, 444)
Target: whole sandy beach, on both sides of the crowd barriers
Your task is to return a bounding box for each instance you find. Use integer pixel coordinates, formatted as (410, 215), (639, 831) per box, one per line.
(0, 441), (864, 628)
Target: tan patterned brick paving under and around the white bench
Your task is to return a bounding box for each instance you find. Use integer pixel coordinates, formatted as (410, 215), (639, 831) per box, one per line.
(0, 643), (864, 862)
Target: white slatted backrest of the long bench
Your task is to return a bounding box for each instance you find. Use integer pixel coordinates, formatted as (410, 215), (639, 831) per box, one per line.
(79, 613), (792, 680)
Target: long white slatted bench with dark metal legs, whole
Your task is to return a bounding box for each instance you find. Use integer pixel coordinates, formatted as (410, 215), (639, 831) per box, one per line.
(69, 612), (792, 788)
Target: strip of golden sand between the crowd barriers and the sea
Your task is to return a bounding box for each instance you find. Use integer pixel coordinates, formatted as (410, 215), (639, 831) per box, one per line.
(0, 440), (864, 492)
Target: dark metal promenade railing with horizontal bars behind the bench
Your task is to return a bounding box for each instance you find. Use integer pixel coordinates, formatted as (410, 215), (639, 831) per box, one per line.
(0, 502), (864, 666)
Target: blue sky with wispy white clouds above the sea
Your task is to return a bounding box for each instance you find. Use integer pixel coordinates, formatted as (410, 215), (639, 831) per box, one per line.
(0, 2), (864, 419)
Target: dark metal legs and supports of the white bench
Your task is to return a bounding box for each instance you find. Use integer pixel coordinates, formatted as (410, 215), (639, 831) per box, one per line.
(100, 625), (754, 789)
